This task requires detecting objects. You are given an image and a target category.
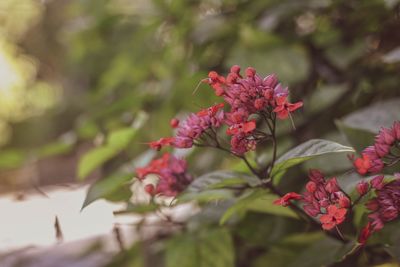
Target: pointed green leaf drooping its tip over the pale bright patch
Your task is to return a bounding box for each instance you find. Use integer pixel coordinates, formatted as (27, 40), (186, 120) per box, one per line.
(82, 174), (132, 209)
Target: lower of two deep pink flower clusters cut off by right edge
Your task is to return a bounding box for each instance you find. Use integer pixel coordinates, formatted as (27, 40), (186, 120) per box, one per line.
(358, 174), (400, 244)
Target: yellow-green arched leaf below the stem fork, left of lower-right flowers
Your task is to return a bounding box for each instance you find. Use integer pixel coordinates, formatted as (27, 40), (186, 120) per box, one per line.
(220, 189), (297, 224)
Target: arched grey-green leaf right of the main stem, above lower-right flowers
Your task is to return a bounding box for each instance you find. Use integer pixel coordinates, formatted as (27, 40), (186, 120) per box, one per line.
(271, 139), (354, 179)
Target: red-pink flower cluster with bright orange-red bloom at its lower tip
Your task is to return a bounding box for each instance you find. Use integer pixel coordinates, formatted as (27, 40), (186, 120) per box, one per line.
(274, 170), (351, 230)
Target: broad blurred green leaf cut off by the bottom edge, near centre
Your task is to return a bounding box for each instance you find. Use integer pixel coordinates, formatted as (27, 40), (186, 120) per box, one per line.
(166, 228), (235, 267)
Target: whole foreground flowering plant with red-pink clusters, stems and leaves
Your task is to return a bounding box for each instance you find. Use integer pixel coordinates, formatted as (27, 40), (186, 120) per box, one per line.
(82, 65), (400, 266)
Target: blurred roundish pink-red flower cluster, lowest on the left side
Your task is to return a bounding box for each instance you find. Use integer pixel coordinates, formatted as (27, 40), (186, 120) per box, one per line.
(136, 153), (192, 196)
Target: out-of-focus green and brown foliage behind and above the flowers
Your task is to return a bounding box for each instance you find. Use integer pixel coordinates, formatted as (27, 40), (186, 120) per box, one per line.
(0, 0), (400, 193)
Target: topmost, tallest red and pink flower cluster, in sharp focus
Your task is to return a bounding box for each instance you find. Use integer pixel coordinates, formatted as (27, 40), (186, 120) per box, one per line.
(204, 65), (303, 155)
